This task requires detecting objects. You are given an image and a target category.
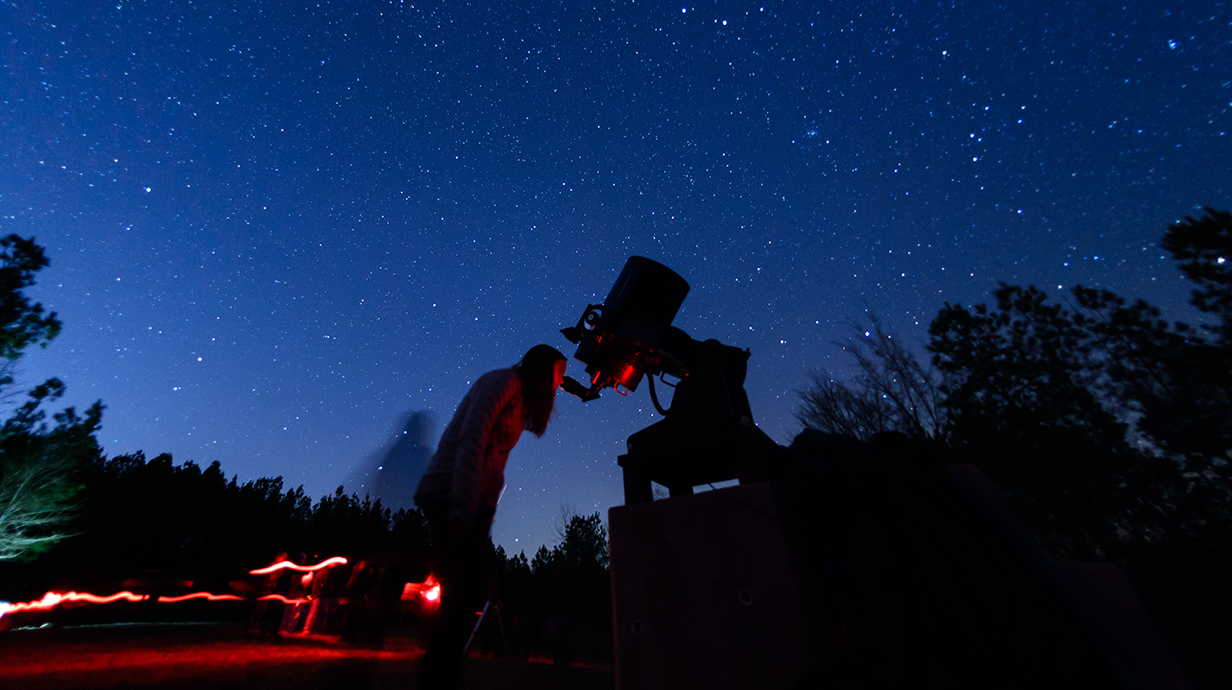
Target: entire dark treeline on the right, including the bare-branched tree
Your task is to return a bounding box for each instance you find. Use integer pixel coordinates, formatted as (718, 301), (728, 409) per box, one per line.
(798, 208), (1232, 688)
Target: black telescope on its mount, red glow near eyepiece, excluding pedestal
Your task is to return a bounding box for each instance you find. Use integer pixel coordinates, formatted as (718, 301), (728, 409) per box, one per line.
(561, 256), (779, 504)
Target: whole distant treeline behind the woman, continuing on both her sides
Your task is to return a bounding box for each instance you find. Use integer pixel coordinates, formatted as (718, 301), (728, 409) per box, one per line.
(0, 452), (612, 660)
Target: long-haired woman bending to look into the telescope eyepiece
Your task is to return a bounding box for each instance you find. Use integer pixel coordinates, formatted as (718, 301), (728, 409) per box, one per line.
(415, 345), (567, 689)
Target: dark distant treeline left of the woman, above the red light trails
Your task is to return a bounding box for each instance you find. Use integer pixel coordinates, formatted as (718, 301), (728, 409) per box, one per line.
(0, 452), (429, 594)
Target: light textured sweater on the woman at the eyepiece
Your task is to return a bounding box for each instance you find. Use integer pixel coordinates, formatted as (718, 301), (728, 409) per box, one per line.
(415, 368), (525, 526)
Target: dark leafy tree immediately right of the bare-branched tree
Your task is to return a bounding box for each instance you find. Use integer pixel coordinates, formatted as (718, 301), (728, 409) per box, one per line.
(929, 285), (1142, 556)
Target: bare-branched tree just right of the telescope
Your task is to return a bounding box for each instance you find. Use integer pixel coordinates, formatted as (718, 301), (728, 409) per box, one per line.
(796, 315), (946, 441)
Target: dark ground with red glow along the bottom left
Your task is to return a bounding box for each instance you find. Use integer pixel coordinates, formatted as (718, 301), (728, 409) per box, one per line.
(0, 625), (615, 690)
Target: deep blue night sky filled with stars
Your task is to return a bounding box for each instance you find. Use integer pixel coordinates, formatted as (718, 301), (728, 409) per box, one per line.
(0, 0), (1232, 554)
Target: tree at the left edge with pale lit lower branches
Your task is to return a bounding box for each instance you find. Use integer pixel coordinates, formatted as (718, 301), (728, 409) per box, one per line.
(0, 235), (102, 561)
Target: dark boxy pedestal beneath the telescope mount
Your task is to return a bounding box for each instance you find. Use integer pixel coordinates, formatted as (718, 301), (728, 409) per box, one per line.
(607, 482), (838, 690)
